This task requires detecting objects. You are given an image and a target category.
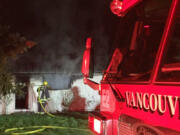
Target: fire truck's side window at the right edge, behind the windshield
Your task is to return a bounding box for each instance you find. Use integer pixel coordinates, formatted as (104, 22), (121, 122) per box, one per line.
(158, 22), (180, 82)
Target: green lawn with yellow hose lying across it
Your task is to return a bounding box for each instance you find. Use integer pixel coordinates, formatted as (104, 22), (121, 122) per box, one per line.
(0, 112), (92, 135)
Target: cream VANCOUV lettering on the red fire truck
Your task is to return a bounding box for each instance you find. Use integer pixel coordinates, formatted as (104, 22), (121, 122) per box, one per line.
(125, 91), (180, 116)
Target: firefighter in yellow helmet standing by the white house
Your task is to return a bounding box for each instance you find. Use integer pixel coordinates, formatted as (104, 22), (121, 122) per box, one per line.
(37, 81), (50, 114)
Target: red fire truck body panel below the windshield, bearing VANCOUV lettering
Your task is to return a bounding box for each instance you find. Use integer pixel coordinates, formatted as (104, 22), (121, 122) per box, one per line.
(100, 84), (180, 131)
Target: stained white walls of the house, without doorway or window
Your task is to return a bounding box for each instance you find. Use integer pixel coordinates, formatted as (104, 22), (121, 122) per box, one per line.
(0, 75), (102, 114)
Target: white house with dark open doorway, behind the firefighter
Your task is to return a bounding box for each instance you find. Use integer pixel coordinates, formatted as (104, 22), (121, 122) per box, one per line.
(0, 73), (102, 114)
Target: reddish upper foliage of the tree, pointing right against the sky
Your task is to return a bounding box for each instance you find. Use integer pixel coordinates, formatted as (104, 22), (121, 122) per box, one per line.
(0, 25), (36, 60)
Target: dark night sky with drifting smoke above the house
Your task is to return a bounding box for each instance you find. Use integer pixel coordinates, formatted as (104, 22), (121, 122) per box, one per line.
(0, 0), (118, 73)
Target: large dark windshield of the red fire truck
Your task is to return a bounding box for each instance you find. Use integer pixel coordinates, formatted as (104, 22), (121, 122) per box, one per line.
(103, 0), (170, 82)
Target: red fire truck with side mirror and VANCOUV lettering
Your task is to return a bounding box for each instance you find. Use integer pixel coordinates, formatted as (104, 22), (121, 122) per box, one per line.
(82, 0), (180, 135)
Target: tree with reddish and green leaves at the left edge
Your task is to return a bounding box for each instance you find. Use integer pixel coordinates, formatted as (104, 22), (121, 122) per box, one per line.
(0, 25), (36, 114)
